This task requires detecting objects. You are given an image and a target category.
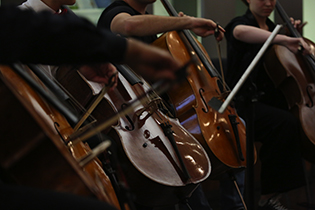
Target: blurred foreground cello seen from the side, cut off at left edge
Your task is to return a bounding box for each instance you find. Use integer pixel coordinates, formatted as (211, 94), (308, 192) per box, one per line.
(0, 66), (120, 209)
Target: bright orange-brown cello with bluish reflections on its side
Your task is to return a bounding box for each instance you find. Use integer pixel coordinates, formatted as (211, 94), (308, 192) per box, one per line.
(153, 0), (253, 178)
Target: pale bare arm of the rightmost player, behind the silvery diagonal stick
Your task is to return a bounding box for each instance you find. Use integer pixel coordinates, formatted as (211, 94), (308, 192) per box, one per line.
(233, 25), (310, 54)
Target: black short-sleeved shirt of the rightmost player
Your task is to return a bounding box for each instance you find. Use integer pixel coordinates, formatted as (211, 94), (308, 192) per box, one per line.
(225, 9), (275, 99)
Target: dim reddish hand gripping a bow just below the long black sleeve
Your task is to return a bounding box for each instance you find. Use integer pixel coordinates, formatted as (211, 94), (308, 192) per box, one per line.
(79, 63), (118, 90)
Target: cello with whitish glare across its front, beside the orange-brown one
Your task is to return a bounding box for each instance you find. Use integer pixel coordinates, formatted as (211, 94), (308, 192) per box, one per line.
(56, 65), (211, 207)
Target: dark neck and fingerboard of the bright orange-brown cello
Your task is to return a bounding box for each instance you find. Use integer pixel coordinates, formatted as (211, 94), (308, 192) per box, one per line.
(161, 0), (219, 77)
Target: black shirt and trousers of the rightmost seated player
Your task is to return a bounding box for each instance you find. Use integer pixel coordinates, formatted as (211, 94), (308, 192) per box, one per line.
(225, 10), (305, 194)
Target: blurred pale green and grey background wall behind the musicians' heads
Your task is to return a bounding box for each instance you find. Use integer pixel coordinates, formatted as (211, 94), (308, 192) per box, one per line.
(0, 0), (315, 58)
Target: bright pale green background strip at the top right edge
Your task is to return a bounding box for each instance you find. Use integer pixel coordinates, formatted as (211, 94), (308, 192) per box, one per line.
(303, 0), (315, 42)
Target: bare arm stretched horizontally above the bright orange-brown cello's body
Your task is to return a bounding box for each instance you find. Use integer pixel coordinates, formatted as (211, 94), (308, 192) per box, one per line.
(111, 13), (224, 40)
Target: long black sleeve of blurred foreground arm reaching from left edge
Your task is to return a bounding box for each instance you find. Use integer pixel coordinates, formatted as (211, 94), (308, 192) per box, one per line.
(0, 7), (127, 65)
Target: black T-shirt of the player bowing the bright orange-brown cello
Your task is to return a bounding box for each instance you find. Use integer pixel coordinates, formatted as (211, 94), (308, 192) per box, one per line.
(97, 1), (157, 44)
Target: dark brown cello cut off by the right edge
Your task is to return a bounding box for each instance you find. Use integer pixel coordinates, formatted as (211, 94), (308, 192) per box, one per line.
(264, 1), (315, 163)
